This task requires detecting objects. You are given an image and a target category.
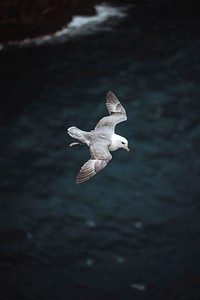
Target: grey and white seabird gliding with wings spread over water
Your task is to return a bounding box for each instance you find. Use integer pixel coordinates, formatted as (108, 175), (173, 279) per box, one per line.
(67, 91), (130, 184)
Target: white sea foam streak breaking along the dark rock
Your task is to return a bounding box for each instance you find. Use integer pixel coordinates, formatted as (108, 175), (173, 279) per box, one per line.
(0, 3), (128, 50)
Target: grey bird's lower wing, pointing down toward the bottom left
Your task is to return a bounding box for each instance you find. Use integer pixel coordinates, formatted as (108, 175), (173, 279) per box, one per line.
(76, 140), (112, 183)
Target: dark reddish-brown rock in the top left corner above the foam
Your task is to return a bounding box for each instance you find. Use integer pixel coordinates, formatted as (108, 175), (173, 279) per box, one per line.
(0, 0), (99, 42)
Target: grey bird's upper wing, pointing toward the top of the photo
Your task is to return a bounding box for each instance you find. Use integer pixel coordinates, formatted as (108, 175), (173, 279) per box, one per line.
(95, 91), (127, 131)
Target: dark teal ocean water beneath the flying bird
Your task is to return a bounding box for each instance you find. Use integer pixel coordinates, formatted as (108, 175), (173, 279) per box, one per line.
(0, 1), (200, 300)
